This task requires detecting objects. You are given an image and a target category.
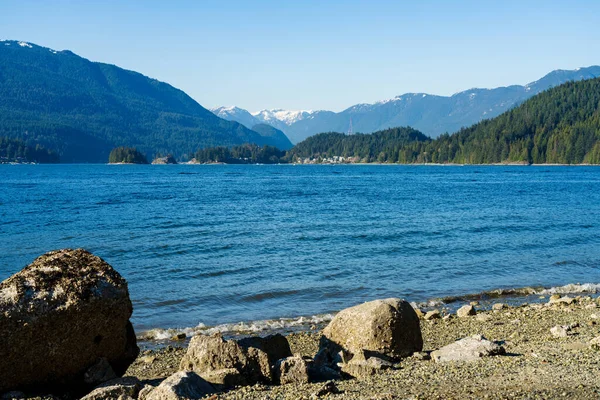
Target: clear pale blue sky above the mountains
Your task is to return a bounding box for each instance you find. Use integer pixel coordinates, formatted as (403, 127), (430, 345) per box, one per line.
(0, 0), (600, 111)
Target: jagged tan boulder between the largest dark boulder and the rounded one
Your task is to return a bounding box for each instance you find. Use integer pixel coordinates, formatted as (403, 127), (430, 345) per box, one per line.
(180, 334), (273, 387)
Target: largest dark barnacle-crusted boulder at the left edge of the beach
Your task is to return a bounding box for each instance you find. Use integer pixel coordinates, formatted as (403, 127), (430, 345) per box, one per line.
(0, 249), (139, 392)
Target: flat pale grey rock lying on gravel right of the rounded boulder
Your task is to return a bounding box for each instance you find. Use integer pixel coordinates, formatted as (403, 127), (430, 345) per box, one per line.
(431, 335), (506, 362)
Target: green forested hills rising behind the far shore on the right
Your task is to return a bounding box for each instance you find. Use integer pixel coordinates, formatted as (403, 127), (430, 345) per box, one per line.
(287, 79), (600, 164)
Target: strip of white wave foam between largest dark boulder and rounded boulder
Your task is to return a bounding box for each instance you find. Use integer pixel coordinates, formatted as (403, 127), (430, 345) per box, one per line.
(138, 314), (333, 340)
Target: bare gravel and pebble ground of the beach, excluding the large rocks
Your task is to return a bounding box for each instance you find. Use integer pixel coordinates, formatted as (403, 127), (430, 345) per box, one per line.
(126, 296), (600, 400)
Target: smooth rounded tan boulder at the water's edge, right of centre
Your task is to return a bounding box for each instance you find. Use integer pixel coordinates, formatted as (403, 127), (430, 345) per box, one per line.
(320, 298), (423, 363)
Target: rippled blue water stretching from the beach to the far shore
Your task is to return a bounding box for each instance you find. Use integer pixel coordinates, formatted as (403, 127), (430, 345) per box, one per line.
(0, 165), (600, 330)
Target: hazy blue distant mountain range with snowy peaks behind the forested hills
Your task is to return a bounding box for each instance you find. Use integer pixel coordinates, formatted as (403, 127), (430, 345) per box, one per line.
(211, 66), (600, 143)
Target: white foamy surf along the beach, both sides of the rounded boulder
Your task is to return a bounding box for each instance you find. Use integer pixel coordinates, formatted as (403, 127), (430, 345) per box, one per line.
(137, 282), (600, 349)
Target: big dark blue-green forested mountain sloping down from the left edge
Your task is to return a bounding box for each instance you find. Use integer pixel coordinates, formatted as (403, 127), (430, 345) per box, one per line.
(0, 41), (288, 162)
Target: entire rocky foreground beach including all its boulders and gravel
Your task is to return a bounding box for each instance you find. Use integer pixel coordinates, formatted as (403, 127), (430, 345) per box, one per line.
(0, 250), (600, 400)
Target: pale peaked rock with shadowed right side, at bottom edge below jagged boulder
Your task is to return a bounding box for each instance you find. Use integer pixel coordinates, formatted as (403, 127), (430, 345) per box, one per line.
(144, 371), (215, 400)
